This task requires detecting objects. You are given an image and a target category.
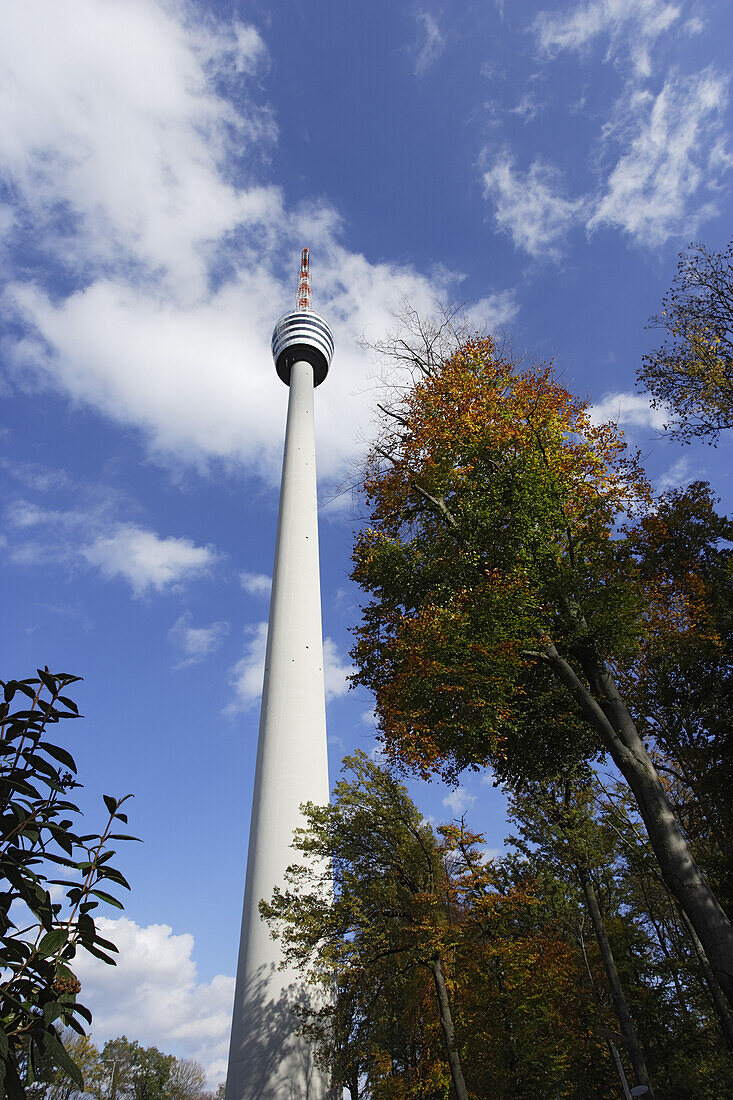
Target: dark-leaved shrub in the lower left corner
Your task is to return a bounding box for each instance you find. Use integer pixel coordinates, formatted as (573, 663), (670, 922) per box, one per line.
(0, 669), (131, 1100)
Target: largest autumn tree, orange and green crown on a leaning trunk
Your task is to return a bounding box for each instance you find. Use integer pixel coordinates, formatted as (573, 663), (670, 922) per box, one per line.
(353, 340), (733, 1001)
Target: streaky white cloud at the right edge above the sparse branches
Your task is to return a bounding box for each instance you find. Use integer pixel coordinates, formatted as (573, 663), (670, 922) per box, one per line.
(588, 69), (733, 245)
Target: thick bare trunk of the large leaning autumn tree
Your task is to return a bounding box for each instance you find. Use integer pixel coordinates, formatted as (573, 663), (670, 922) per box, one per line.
(543, 638), (733, 1005)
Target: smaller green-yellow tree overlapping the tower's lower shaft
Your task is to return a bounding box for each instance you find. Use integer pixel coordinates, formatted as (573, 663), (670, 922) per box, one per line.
(261, 752), (469, 1100)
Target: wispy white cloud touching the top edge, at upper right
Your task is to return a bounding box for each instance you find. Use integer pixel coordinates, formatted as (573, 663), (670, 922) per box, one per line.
(533, 0), (682, 76)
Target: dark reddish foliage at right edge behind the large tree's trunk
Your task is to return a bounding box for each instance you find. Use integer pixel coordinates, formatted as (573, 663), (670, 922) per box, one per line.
(623, 482), (733, 912)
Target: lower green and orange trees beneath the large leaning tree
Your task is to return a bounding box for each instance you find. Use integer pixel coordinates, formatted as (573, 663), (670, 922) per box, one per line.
(262, 754), (638, 1100)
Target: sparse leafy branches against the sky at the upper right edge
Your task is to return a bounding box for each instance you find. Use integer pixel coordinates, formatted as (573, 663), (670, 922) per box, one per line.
(638, 241), (733, 443)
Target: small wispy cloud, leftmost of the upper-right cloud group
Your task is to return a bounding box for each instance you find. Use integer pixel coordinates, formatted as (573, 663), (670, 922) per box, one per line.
(483, 153), (586, 259)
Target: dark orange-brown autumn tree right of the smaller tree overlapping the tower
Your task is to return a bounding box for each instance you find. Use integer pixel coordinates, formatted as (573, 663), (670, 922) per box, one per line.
(438, 822), (614, 1100)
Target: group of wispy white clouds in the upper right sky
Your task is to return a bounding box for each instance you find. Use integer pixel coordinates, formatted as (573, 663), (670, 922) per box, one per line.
(483, 0), (733, 261)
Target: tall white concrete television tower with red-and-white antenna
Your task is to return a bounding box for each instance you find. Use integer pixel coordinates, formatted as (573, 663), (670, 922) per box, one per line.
(227, 249), (333, 1100)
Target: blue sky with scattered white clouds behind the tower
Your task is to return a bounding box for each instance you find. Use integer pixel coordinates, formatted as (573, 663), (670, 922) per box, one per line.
(0, 0), (733, 1080)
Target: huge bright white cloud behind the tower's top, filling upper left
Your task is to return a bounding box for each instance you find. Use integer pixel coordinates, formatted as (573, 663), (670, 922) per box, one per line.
(0, 0), (512, 484)
